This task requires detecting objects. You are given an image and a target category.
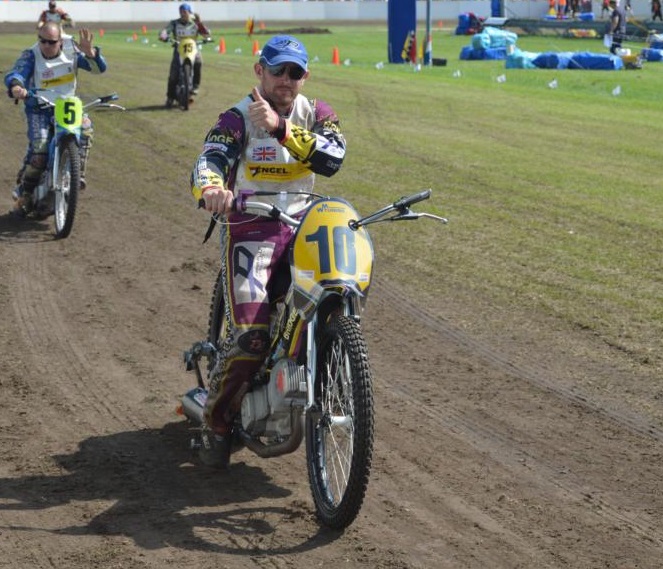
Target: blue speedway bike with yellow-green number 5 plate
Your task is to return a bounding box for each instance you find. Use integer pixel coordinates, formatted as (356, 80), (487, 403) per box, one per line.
(13, 89), (125, 239)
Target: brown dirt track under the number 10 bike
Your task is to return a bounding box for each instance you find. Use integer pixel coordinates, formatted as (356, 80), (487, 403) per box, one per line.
(0, 36), (663, 569)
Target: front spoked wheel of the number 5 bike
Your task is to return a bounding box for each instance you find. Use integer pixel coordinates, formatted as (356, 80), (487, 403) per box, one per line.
(54, 138), (81, 239)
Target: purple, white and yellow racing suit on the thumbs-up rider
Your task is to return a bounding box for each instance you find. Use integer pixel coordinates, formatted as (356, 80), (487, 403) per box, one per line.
(191, 94), (345, 434)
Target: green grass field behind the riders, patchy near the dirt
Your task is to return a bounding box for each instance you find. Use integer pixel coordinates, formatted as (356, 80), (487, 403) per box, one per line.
(0, 25), (663, 367)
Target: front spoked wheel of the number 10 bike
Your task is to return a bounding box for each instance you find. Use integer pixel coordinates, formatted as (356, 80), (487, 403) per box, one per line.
(306, 310), (374, 529)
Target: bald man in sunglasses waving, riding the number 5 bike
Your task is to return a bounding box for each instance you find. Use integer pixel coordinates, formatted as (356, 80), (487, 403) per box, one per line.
(5, 22), (106, 210)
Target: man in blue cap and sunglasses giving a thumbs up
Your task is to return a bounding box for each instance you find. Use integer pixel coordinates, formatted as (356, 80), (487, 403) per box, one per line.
(191, 36), (345, 468)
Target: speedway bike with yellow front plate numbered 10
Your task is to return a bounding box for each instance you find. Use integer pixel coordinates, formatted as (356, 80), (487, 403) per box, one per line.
(184, 190), (447, 529)
